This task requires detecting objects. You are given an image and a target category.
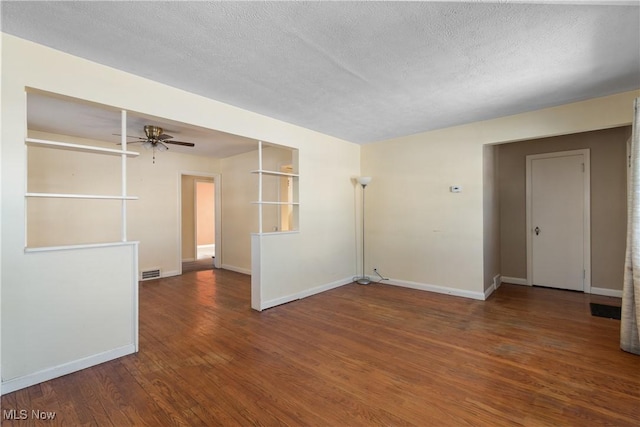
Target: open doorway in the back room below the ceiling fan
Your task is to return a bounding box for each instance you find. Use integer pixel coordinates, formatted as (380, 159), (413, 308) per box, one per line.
(179, 172), (222, 272)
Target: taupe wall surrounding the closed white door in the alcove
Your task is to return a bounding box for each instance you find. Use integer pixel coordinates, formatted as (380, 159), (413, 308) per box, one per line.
(498, 126), (631, 290)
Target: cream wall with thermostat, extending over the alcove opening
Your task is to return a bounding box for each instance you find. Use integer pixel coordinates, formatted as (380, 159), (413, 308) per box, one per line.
(362, 91), (640, 299)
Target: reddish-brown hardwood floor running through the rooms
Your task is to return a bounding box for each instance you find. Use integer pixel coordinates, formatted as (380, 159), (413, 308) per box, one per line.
(2, 270), (640, 426)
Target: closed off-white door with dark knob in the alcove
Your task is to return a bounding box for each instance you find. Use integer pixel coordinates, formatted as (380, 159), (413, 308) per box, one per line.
(527, 150), (590, 292)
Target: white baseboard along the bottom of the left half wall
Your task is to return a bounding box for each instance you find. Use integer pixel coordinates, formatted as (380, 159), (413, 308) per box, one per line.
(2, 344), (136, 395)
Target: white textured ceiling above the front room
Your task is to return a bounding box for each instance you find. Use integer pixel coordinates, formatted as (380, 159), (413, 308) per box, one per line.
(1, 1), (640, 143)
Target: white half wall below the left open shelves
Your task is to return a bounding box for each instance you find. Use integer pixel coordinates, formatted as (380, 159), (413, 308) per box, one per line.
(2, 242), (138, 394)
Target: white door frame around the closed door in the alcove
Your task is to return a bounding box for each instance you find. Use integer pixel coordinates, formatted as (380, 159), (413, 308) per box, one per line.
(526, 148), (591, 294)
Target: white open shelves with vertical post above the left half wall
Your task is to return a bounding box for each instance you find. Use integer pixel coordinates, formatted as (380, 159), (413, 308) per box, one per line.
(25, 110), (140, 252)
